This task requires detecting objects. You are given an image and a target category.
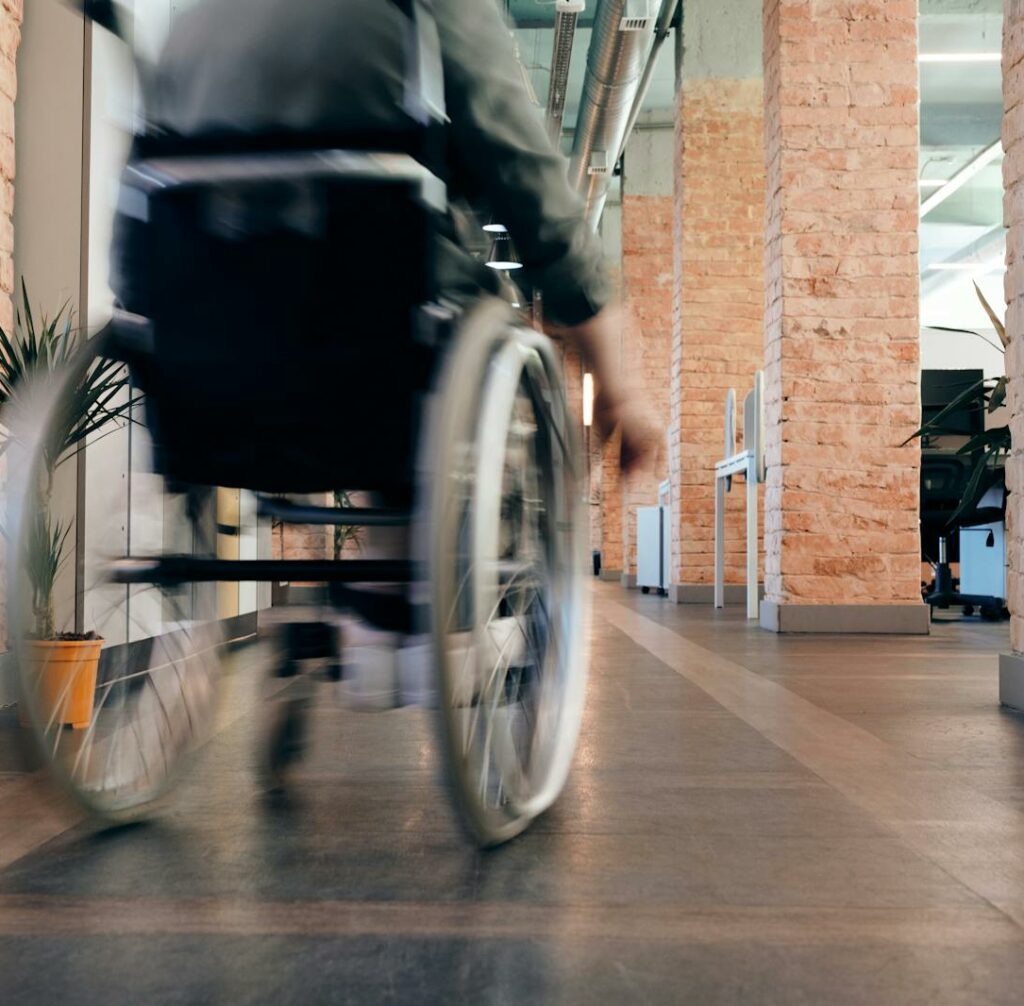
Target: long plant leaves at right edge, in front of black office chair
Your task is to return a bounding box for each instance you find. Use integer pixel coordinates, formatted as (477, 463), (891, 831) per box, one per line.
(903, 283), (1011, 525)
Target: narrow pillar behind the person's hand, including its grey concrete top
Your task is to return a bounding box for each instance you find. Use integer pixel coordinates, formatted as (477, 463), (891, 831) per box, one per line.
(621, 120), (673, 586)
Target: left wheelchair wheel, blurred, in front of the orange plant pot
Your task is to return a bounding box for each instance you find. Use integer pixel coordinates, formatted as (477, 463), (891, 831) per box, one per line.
(3, 336), (223, 823)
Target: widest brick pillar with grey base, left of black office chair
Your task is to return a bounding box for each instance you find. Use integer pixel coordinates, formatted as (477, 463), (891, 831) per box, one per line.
(762, 0), (928, 632)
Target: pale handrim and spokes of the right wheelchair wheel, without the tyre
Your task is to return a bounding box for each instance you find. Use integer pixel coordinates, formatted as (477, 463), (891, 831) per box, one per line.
(438, 329), (582, 841)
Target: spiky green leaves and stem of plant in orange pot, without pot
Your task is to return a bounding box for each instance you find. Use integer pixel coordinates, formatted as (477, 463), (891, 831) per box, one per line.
(0, 282), (138, 639)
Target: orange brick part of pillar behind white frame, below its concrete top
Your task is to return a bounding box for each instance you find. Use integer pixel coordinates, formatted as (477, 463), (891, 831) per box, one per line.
(671, 79), (765, 585)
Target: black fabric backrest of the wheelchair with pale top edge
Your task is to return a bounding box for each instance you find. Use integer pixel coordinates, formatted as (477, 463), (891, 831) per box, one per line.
(113, 142), (443, 492)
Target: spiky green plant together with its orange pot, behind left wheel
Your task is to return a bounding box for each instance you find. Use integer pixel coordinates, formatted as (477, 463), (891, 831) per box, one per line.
(0, 283), (132, 728)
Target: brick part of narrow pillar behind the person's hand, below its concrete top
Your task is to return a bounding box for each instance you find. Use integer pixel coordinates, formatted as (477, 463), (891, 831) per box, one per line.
(605, 193), (674, 574)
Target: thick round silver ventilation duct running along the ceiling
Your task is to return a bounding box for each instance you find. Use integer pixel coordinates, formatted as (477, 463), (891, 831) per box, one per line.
(569, 0), (657, 229)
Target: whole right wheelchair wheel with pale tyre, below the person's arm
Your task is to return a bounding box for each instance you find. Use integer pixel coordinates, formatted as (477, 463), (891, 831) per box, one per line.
(428, 301), (586, 845)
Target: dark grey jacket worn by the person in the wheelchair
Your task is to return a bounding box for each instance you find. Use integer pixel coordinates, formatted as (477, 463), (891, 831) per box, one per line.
(150, 0), (607, 325)
